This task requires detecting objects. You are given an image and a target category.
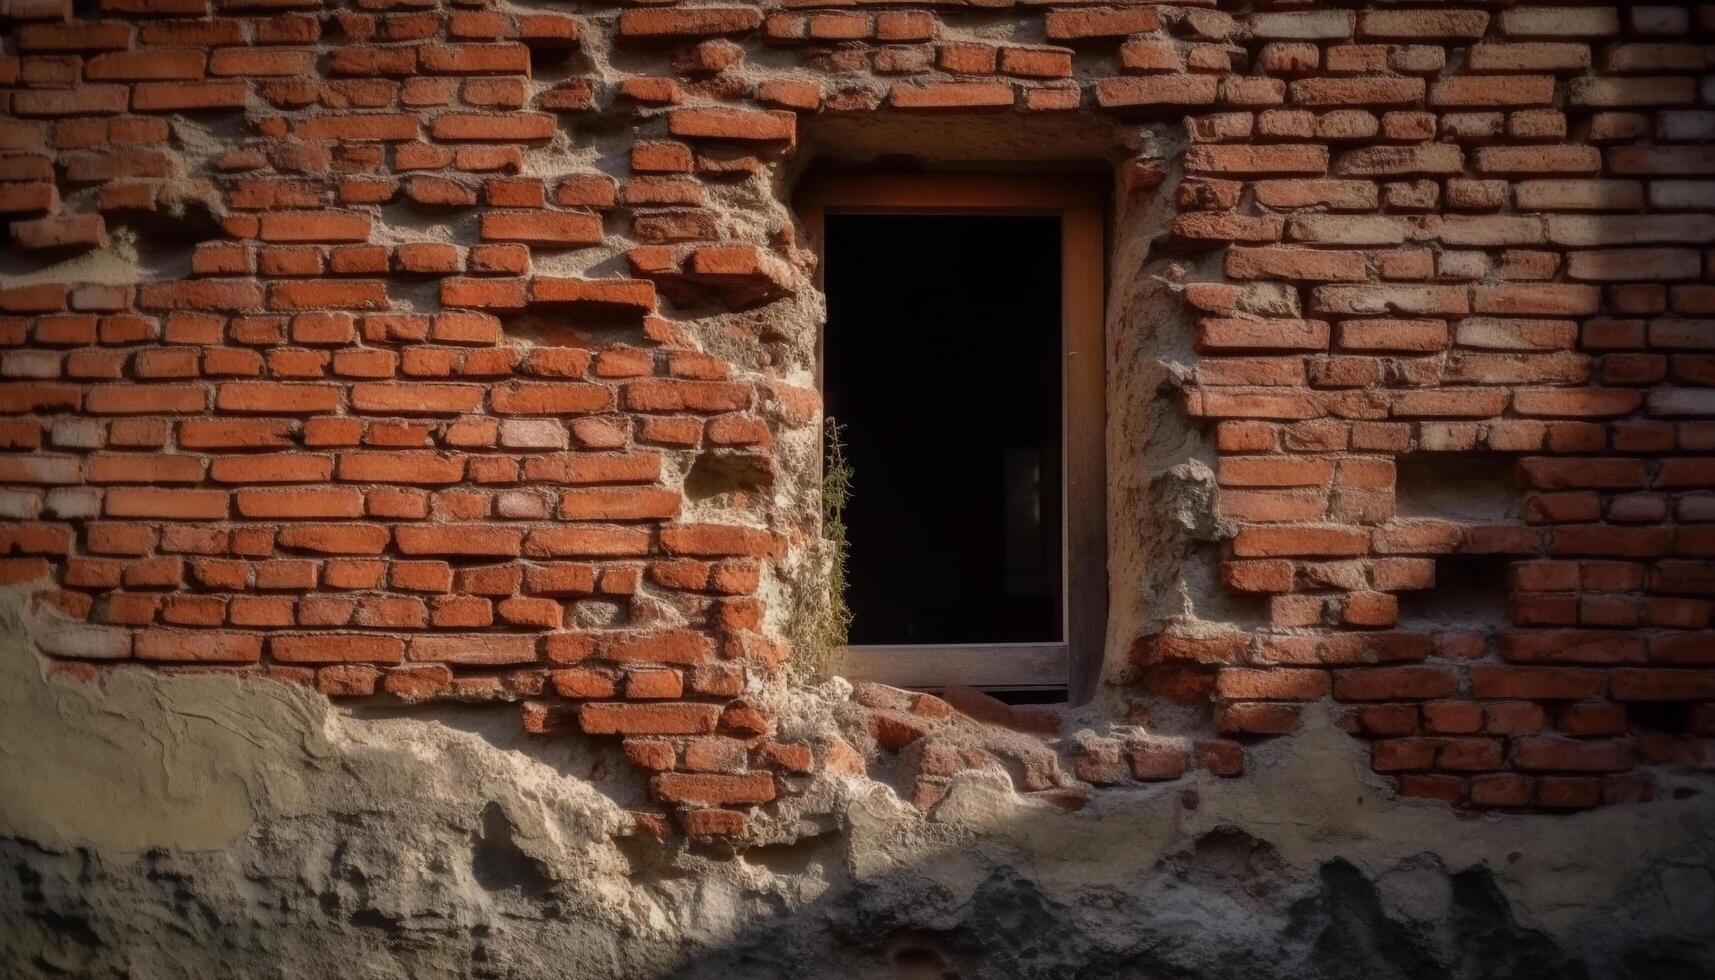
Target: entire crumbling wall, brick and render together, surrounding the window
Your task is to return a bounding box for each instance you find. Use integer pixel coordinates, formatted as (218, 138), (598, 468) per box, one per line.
(0, 0), (1715, 978)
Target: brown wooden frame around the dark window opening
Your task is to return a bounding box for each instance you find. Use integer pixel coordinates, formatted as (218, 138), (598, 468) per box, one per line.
(796, 173), (1108, 704)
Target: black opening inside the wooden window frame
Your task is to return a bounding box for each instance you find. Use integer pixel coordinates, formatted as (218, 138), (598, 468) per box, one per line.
(823, 215), (1062, 644)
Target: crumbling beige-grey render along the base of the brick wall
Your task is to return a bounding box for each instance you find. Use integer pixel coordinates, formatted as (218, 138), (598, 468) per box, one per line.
(0, 590), (1715, 980)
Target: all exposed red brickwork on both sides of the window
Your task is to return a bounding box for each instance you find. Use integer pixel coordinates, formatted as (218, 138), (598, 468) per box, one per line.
(0, 0), (1715, 832)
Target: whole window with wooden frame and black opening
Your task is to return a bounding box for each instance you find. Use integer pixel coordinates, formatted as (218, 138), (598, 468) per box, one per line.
(803, 175), (1106, 700)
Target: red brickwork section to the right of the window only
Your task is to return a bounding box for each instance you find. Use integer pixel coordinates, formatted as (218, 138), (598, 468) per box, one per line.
(1135, 5), (1715, 807)
